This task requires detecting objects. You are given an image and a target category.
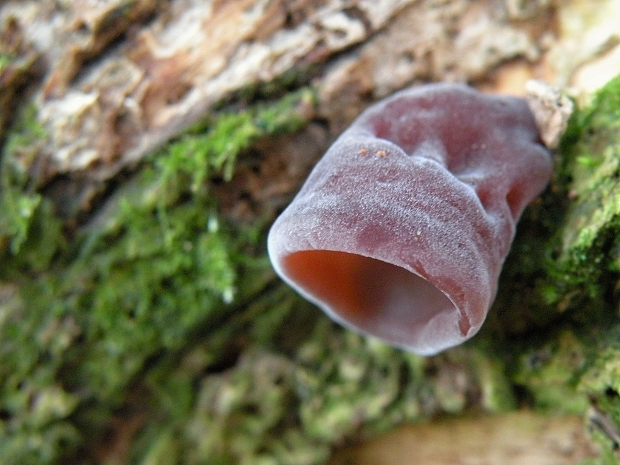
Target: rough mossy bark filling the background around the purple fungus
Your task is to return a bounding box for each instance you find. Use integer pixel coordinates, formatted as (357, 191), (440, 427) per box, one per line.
(0, 0), (620, 465)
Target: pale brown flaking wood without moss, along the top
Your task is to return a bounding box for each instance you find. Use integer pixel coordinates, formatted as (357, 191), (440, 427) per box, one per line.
(1, 0), (604, 189)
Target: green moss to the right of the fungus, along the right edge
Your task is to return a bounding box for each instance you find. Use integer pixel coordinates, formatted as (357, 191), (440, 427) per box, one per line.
(499, 72), (620, 456)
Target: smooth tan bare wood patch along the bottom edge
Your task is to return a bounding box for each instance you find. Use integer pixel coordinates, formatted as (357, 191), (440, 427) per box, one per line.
(329, 412), (596, 465)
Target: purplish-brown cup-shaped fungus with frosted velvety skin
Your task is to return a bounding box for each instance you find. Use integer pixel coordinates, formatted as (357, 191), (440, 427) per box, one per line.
(268, 84), (553, 355)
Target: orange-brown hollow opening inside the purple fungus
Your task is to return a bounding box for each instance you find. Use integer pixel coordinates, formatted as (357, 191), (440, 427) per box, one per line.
(283, 250), (458, 346)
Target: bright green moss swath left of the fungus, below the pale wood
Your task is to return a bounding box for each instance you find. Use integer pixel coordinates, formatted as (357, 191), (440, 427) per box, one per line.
(0, 90), (313, 465)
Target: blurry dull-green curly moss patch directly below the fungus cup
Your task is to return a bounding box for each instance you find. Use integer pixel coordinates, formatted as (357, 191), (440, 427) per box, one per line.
(134, 314), (524, 465)
